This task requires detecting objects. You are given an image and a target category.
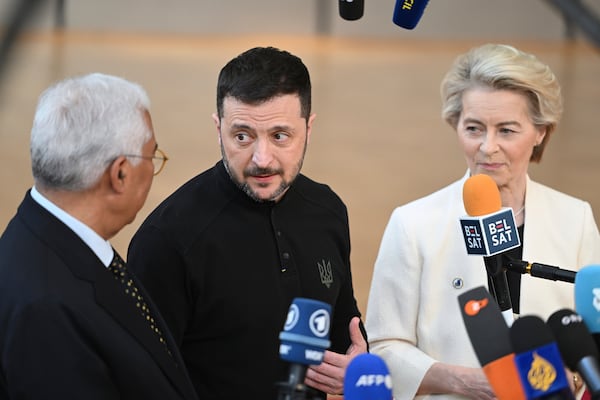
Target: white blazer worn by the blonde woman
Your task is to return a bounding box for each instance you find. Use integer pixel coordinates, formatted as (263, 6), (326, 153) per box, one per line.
(366, 172), (600, 400)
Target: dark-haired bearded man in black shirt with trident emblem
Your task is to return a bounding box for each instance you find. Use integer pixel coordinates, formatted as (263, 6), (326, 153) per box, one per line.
(128, 47), (367, 400)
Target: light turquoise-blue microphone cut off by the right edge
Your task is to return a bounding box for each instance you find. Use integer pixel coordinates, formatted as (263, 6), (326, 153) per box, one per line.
(575, 265), (600, 349)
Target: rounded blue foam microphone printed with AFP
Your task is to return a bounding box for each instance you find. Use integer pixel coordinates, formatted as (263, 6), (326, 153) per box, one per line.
(344, 353), (393, 400)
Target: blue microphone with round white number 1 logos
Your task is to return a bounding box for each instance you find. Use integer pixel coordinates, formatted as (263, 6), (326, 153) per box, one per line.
(277, 297), (331, 400)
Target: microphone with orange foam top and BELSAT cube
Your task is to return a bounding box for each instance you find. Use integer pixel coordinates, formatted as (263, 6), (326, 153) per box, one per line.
(460, 174), (521, 324)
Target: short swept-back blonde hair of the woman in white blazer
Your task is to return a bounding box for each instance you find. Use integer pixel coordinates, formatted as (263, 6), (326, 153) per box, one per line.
(441, 44), (563, 162)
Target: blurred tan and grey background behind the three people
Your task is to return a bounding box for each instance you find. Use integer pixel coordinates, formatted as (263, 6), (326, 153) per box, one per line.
(0, 0), (600, 312)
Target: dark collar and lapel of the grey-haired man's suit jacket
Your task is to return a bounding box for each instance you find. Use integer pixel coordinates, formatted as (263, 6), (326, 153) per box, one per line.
(19, 193), (196, 398)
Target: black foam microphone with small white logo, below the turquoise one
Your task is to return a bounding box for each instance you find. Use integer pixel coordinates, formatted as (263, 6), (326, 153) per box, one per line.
(547, 309), (600, 400)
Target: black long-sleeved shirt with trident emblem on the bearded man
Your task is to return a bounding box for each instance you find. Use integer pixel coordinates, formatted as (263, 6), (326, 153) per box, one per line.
(128, 161), (360, 400)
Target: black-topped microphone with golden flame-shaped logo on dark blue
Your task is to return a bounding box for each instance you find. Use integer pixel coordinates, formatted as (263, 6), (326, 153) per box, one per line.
(509, 315), (574, 400)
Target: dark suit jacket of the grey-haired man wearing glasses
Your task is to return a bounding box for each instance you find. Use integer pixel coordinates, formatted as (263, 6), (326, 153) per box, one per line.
(0, 192), (197, 400)
